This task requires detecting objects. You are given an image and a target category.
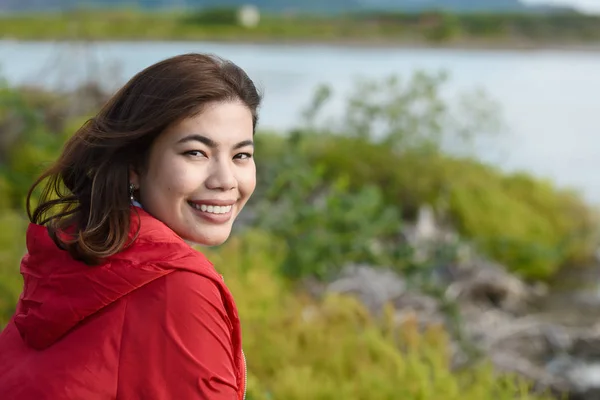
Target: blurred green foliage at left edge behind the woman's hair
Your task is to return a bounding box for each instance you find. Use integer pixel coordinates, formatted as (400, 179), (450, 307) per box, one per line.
(0, 82), (62, 327)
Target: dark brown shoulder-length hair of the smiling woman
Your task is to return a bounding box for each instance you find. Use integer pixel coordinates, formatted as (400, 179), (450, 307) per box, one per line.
(27, 54), (261, 265)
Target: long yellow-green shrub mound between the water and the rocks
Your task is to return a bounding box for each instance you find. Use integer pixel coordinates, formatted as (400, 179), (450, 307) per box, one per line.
(302, 134), (598, 279)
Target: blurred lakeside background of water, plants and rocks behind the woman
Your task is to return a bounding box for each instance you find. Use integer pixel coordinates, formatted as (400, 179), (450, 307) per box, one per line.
(0, 0), (600, 400)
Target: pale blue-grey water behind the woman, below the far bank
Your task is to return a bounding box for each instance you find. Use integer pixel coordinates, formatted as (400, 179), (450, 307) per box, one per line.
(0, 41), (600, 203)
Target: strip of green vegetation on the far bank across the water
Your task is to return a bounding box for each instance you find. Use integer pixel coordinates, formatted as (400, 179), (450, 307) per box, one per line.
(0, 9), (600, 46)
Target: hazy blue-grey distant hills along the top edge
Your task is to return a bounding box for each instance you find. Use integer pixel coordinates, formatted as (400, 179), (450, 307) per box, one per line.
(0, 0), (574, 14)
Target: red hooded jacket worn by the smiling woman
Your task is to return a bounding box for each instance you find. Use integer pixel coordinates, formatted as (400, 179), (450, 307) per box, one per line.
(0, 210), (246, 400)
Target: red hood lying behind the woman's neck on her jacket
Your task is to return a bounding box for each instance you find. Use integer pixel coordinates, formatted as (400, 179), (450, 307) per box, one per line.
(14, 209), (220, 350)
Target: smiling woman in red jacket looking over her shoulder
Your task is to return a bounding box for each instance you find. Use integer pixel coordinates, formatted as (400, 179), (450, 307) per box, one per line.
(0, 54), (260, 400)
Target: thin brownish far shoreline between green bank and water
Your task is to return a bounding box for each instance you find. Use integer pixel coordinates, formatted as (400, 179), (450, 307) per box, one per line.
(0, 36), (600, 53)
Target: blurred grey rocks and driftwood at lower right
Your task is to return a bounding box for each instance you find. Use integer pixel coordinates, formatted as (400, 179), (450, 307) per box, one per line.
(318, 250), (600, 400)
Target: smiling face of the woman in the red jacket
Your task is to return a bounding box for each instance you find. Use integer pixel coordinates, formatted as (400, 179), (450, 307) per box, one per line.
(131, 101), (256, 246)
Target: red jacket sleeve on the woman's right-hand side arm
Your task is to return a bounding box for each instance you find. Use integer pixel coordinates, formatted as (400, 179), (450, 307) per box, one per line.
(117, 271), (238, 400)
